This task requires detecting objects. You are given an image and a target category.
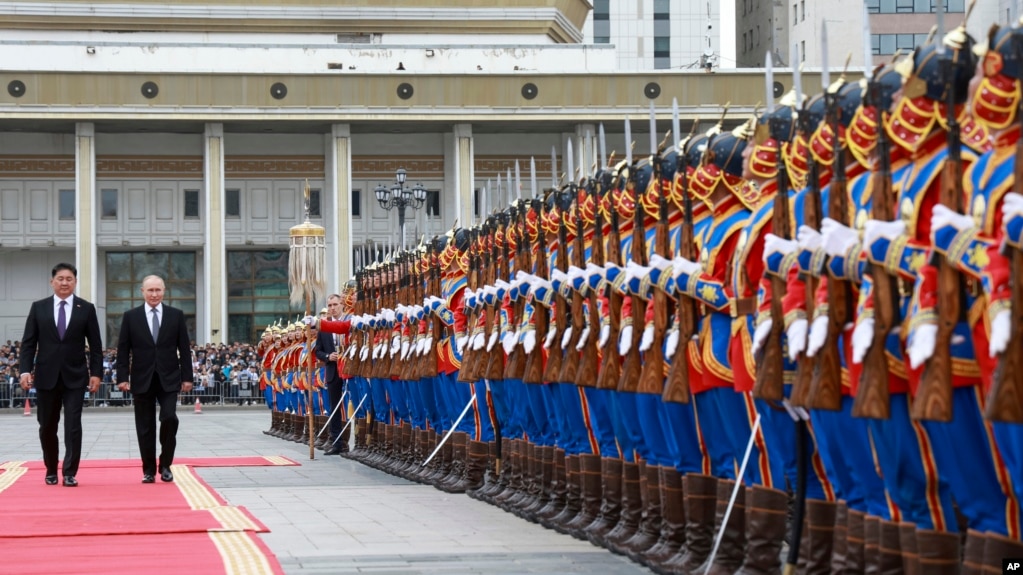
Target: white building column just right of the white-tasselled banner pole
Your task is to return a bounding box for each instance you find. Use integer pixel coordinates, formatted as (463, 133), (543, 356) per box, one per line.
(333, 124), (354, 286)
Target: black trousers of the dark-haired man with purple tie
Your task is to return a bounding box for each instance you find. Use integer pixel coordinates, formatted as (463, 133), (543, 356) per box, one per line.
(35, 375), (86, 476)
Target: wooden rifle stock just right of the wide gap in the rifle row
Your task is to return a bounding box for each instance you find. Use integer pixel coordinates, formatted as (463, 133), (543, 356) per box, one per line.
(757, 140), (792, 401)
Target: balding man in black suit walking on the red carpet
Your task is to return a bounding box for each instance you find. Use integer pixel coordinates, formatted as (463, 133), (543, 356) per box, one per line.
(118, 275), (192, 483)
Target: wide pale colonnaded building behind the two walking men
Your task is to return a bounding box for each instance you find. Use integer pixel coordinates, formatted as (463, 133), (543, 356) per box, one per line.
(0, 0), (797, 346)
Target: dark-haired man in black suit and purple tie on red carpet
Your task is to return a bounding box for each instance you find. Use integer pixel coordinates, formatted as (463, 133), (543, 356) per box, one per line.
(20, 263), (103, 487)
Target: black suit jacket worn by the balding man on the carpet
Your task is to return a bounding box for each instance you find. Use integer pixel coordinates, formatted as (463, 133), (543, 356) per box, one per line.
(117, 304), (193, 394)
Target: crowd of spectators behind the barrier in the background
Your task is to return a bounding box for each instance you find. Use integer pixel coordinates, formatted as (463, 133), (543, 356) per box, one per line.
(0, 340), (260, 408)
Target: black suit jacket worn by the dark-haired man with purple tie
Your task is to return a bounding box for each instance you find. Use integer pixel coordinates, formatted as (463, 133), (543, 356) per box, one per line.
(20, 296), (103, 390)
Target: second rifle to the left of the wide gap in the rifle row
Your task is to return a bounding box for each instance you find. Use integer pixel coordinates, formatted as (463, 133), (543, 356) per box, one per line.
(636, 144), (674, 394)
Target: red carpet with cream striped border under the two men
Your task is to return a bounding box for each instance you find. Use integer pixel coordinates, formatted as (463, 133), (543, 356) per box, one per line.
(0, 457), (299, 574)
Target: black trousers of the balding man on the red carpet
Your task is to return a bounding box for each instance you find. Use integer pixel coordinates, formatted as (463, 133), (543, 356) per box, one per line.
(133, 374), (178, 475)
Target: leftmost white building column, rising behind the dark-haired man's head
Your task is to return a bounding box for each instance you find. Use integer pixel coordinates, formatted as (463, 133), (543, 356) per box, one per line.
(75, 122), (96, 308)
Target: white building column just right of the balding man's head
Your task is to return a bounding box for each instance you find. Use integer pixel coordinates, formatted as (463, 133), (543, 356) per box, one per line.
(196, 124), (227, 344)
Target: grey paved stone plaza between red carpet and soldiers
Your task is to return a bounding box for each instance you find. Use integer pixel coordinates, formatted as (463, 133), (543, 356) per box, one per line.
(0, 407), (650, 575)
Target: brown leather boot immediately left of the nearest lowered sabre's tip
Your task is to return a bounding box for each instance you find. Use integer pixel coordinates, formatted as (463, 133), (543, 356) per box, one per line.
(651, 473), (717, 575)
